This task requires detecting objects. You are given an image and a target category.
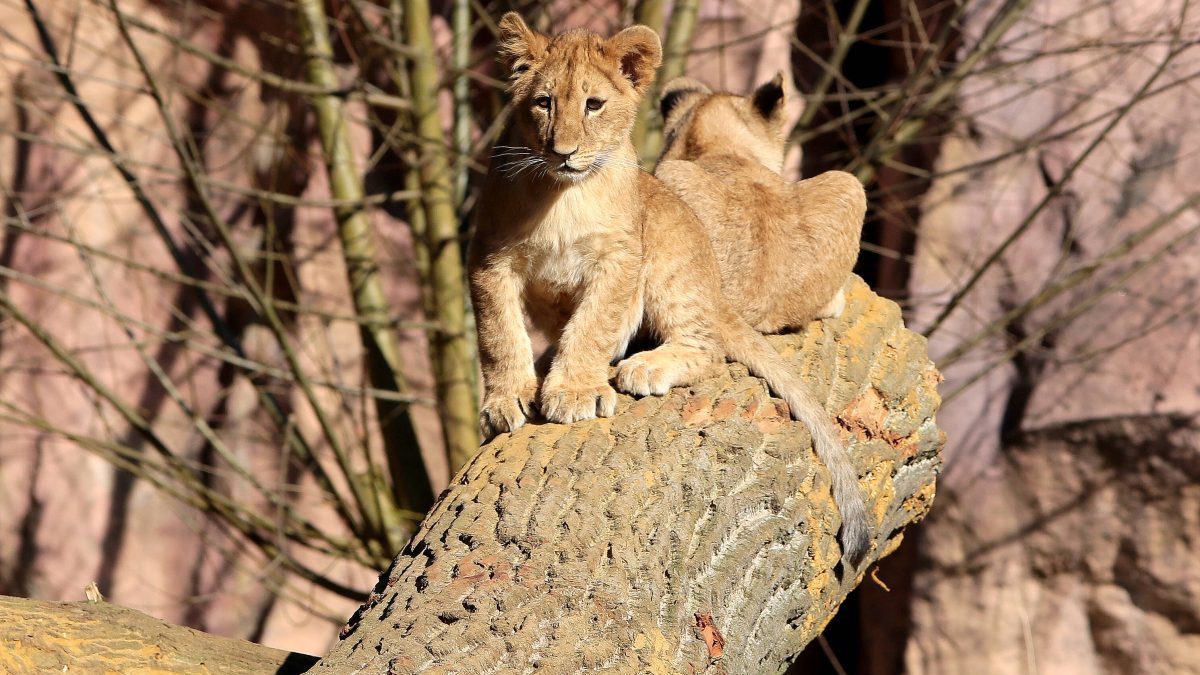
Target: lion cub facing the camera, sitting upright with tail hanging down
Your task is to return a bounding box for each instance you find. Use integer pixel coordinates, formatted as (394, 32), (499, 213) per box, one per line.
(469, 12), (870, 566)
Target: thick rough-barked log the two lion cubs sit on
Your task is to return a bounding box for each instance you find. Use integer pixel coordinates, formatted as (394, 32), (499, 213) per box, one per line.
(314, 279), (943, 675)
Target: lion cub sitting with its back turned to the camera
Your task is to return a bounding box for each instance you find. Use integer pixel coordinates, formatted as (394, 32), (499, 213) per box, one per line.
(654, 74), (866, 333)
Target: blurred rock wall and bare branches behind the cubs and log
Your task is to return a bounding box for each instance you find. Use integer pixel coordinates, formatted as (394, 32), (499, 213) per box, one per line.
(0, 0), (1200, 675)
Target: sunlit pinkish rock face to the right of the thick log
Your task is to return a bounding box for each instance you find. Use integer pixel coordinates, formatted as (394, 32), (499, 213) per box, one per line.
(902, 1), (1200, 674)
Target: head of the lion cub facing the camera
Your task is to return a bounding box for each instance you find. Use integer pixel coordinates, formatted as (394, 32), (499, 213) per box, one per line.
(493, 12), (662, 181)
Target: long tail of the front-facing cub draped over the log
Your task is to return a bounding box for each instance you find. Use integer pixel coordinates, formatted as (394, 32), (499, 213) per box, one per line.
(722, 310), (871, 568)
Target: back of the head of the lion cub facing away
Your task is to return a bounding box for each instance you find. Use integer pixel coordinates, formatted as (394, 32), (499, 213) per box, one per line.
(659, 73), (787, 172)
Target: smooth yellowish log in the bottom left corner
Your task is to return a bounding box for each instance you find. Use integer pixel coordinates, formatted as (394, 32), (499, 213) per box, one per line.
(0, 596), (317, 675)
